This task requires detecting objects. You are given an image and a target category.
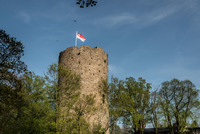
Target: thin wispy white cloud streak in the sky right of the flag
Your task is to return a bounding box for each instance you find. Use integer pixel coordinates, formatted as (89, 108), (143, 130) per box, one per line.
(94, 3), (186, 28)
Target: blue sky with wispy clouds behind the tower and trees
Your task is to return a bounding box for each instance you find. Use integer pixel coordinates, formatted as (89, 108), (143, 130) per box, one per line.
(0, 0), (200, 88)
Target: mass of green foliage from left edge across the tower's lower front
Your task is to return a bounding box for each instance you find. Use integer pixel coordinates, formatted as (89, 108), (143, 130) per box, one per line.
(0, 60), (102, 134)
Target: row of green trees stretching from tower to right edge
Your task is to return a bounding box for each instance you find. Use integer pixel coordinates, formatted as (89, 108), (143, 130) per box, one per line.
(109, 77), (200, 133)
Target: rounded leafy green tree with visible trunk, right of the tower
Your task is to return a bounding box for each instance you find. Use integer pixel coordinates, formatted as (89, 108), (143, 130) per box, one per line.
(122, 77), (151, 134)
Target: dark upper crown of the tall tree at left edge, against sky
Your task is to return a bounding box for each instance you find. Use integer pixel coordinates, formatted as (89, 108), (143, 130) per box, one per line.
(0, 29), (26, 74)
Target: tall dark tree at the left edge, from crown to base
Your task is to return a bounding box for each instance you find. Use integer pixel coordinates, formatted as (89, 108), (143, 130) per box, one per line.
(0, 30), (26, 133)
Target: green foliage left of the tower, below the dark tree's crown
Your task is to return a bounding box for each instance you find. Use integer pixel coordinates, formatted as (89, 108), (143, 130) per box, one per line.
(1, 62), (55, 134)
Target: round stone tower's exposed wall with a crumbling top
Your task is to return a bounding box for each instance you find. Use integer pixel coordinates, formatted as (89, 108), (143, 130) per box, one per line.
(59, 46), (109, 134)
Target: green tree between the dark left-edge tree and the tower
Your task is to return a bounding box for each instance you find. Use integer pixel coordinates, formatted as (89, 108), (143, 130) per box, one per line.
(16, 72), (56, 134)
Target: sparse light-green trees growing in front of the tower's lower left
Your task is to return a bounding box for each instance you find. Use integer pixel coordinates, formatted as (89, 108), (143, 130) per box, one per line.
(50, 64), (101, 134)
